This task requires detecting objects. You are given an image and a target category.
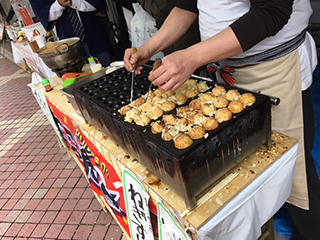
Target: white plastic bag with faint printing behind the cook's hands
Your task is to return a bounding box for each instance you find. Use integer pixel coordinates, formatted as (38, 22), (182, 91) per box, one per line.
(131, 3), (164, 60)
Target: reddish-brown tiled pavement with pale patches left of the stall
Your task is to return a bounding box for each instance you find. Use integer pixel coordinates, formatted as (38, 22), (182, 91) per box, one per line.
(0, 43), (125, 240)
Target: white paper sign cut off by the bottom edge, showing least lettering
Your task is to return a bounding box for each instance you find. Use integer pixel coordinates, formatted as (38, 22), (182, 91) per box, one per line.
(157, 200), (190, 240)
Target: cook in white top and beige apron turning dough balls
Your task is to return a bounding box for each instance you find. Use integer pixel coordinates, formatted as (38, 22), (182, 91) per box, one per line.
(124, 0), (320, 240)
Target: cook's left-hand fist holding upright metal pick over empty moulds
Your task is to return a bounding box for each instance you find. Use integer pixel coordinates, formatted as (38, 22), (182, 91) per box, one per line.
(123, 46), (151, 74)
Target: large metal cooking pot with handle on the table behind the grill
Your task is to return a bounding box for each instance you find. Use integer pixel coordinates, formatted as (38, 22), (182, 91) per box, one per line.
(37, 37), (83, 70)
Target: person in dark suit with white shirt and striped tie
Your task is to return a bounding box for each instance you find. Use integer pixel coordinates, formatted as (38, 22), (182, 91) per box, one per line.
(30, 0), (111, 67)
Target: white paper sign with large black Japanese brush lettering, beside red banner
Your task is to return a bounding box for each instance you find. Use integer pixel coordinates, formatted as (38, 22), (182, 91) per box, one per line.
(122, 169), (154, 240)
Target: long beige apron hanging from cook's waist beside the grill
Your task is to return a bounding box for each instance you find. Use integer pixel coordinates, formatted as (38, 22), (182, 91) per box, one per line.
(216, 50), (309, 210)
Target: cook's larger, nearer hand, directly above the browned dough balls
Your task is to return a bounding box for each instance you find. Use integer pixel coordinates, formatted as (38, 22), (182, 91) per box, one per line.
(149, 50), (197, 91)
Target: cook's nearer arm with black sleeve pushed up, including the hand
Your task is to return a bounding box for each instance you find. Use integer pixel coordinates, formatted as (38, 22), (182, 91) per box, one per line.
(149, 0), (293, 90)
